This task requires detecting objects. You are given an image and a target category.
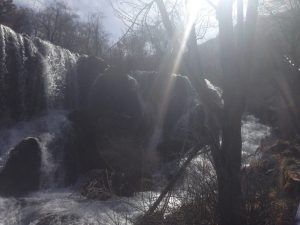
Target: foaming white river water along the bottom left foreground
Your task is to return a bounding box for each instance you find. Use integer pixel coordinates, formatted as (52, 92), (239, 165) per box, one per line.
(0, 189), (162, 225)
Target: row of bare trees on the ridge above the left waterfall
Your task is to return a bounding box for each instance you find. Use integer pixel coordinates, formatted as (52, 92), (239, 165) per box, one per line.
(11, 1), (109, 57)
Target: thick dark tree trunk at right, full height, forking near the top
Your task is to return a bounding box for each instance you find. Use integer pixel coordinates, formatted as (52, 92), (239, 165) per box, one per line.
(213, 0), (257, 225)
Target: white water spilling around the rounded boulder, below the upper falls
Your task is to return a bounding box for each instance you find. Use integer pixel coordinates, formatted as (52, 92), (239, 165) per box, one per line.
(0, 111), (71, 188)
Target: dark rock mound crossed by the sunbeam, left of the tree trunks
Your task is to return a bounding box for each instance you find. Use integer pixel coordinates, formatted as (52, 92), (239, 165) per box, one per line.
(132, 71), (197, 161)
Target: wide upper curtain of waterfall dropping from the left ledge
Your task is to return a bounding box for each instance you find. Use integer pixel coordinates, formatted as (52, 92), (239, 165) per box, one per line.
(0, 25), (80, 120)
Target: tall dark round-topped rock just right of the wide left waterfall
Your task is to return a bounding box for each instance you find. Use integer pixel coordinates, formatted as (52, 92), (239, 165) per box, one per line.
(66, 68), (145, 192)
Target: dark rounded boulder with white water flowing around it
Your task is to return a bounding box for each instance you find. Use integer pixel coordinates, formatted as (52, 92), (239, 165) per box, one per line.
(0, 138), (41, 196)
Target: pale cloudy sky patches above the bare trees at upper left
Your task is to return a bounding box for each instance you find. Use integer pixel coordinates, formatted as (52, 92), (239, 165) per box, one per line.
(14, 0), (124, 41)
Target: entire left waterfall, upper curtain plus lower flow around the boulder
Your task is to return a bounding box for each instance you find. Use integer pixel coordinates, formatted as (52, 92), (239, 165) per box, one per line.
(0, 25), (81, 188)
